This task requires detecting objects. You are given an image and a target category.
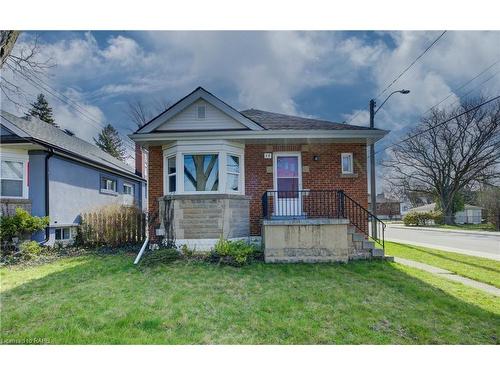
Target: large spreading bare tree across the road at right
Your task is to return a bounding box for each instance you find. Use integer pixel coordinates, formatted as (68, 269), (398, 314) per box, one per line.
(384, 98), (500, 224)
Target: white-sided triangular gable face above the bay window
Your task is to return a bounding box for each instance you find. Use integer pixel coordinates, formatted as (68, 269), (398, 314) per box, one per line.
(156, 99), (248, 131)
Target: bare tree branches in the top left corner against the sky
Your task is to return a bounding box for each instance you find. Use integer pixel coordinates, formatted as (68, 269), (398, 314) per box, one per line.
(0, 30), (54, 107)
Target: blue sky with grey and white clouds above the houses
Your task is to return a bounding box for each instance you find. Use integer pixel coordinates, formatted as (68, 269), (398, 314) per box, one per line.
(2, 31), (500, 185)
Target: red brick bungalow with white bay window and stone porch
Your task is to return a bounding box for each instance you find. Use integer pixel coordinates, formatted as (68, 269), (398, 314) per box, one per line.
(130, 87), (387, 262)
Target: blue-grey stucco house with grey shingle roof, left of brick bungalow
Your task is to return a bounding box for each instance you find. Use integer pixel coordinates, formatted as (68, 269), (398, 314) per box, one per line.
(0, 111), (147, 245)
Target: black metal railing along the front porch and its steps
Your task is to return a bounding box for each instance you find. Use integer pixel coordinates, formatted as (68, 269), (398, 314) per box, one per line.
(262, 190), (386, 248)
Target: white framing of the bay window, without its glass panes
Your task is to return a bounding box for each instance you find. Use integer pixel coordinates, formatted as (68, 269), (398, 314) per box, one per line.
(163, 140), (245, 195)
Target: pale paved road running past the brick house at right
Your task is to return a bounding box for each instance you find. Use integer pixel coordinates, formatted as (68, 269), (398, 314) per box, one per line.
(385, 225), (500, 260)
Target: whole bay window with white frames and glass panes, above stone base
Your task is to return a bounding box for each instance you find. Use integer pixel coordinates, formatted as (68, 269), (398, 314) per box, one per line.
(163, 141), (244, 194)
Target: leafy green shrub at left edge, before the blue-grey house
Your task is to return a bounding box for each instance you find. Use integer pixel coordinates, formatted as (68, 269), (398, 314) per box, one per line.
(0, 208), (49, 242)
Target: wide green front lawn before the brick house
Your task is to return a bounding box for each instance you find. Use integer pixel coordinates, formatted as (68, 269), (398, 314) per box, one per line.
(0, 255), (500, 344)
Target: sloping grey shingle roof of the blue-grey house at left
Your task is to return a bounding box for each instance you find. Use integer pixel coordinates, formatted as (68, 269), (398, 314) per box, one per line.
(0, 110), (143, 180)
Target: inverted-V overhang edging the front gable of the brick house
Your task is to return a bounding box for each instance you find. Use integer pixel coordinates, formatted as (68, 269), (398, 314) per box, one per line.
(135, 86), (263, 134)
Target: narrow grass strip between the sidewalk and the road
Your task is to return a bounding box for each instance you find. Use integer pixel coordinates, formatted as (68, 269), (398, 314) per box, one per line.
(385, 242), (500, 288)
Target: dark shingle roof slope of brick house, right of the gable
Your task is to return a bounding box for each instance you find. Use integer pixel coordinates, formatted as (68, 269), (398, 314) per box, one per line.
(240, 109), (370, 130)
